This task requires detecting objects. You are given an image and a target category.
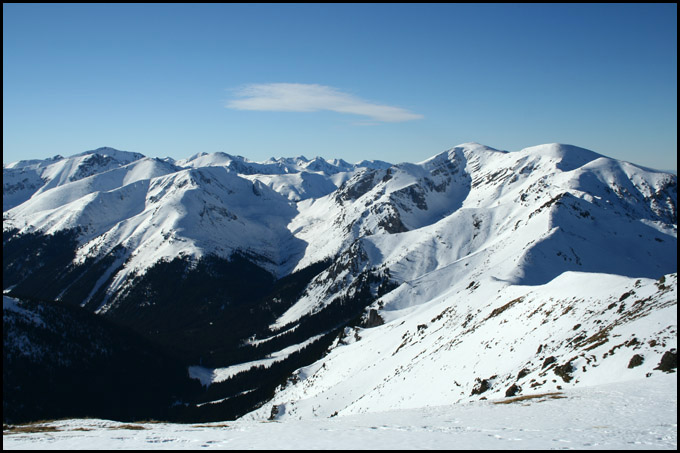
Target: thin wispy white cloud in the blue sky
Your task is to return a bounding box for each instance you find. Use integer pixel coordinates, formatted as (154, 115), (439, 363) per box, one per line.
(227, 83), (423, 123)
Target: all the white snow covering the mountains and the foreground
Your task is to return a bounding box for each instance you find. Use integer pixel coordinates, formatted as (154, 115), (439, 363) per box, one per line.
(3, 143), (677, 449)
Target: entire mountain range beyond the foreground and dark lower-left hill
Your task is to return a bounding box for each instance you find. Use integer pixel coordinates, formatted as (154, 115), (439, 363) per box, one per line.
(3, 143), (677, 418)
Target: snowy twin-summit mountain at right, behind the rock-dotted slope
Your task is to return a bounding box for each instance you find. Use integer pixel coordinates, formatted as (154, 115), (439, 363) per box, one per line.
(266, 144), (677, 327)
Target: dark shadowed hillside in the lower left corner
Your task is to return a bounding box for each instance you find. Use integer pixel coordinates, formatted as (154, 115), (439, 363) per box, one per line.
(2, 297), (197, 423)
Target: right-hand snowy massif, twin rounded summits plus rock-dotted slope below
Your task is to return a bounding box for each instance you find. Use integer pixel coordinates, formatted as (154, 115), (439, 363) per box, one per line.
(236, 144), (677, 418)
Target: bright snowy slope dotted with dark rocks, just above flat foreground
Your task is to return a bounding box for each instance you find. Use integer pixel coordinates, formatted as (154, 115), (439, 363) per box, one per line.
(247, 273), (677, 419)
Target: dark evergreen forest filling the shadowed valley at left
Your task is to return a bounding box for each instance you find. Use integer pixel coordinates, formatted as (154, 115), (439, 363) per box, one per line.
(3, 230), (393, 423)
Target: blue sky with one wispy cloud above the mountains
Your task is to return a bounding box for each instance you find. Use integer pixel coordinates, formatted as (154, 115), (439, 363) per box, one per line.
(3, 4), (677, 169)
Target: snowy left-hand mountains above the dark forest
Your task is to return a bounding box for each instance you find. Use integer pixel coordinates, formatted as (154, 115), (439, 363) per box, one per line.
(3, 148), (406, 282)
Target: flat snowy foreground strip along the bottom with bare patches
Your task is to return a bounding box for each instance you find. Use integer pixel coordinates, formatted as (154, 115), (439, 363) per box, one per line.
(3, 373), (678, 450)
